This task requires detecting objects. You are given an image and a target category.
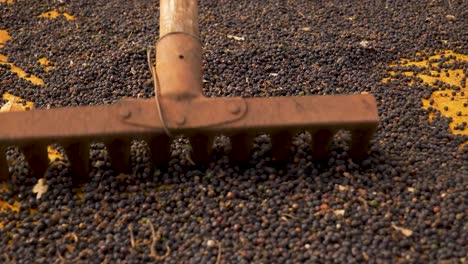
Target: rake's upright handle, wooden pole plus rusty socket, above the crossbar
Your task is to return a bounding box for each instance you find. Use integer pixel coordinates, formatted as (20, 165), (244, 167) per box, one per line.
(155, 0), (203, 100)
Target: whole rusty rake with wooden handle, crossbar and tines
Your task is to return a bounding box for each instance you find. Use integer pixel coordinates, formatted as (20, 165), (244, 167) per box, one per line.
(0, 0), (378, 180)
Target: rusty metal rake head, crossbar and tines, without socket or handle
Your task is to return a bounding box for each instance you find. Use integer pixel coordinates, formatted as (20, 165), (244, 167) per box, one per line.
(0, 95), (378, 177)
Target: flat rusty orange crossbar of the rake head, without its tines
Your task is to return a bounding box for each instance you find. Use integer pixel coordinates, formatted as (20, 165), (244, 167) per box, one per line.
(0, 95), (378, 146)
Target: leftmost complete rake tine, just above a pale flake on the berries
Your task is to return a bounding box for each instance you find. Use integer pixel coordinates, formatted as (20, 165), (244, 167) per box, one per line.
(21, 144), (49, 177)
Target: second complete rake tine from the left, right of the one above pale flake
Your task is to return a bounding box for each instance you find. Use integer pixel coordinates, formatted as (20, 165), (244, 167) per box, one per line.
(65, 142), (90, 179)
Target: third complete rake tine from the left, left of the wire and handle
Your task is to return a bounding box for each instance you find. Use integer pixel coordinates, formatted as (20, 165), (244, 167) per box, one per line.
(106, 139), (131, 174)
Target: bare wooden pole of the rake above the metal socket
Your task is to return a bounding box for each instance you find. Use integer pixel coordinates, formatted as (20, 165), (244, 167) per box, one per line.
(159, 0), (199, 37)
